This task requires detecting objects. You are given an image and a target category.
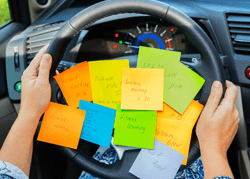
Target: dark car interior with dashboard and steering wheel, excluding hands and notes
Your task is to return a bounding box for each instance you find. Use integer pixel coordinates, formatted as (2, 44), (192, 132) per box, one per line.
(0, 0), (250, 179)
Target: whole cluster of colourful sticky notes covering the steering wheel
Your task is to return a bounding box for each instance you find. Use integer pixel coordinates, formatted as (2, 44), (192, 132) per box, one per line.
(38, 47), (205, 178)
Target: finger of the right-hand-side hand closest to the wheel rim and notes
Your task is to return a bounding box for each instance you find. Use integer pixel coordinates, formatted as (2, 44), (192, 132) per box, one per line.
(204, 81), (222, 113)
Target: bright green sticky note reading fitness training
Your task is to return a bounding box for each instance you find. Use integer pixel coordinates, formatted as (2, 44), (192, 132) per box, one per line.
(113, 104), (157, 149)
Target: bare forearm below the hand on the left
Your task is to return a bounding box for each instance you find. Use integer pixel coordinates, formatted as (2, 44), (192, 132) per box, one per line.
(0, 112), (40, 176)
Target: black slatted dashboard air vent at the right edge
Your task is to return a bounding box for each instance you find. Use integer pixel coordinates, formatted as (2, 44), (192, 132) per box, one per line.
(227, 14), (250, 54)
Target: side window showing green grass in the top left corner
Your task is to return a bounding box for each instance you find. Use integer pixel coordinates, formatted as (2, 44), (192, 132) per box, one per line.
(0, 0), (11, 27)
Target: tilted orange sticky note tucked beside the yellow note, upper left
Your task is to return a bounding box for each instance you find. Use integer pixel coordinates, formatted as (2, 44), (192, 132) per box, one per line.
(54, 62), (92, 108)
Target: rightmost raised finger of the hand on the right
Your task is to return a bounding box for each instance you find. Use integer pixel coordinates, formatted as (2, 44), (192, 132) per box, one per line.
(221, 81), (237, 105)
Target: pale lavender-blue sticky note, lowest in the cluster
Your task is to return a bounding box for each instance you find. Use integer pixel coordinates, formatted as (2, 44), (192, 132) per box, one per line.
(129, 140), (185, 179)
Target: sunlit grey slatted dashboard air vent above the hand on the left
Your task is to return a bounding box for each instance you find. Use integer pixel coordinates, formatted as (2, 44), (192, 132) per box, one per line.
(26, 22), (64, 60)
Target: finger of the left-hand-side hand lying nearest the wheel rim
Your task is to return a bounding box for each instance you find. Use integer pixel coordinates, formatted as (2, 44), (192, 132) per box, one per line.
(38, 54), (52, 82)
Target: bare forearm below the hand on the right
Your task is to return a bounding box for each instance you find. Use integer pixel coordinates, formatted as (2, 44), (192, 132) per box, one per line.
(201, 147), (233, 179)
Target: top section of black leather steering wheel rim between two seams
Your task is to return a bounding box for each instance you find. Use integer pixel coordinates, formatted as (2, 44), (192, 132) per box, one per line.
(69, 0), (169, 31)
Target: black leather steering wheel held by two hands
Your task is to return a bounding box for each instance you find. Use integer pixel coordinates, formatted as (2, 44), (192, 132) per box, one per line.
(47, 0), (225, 179)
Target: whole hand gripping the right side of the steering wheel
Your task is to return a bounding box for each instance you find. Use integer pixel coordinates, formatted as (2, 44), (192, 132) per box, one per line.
(196, 81), (239, 157)
